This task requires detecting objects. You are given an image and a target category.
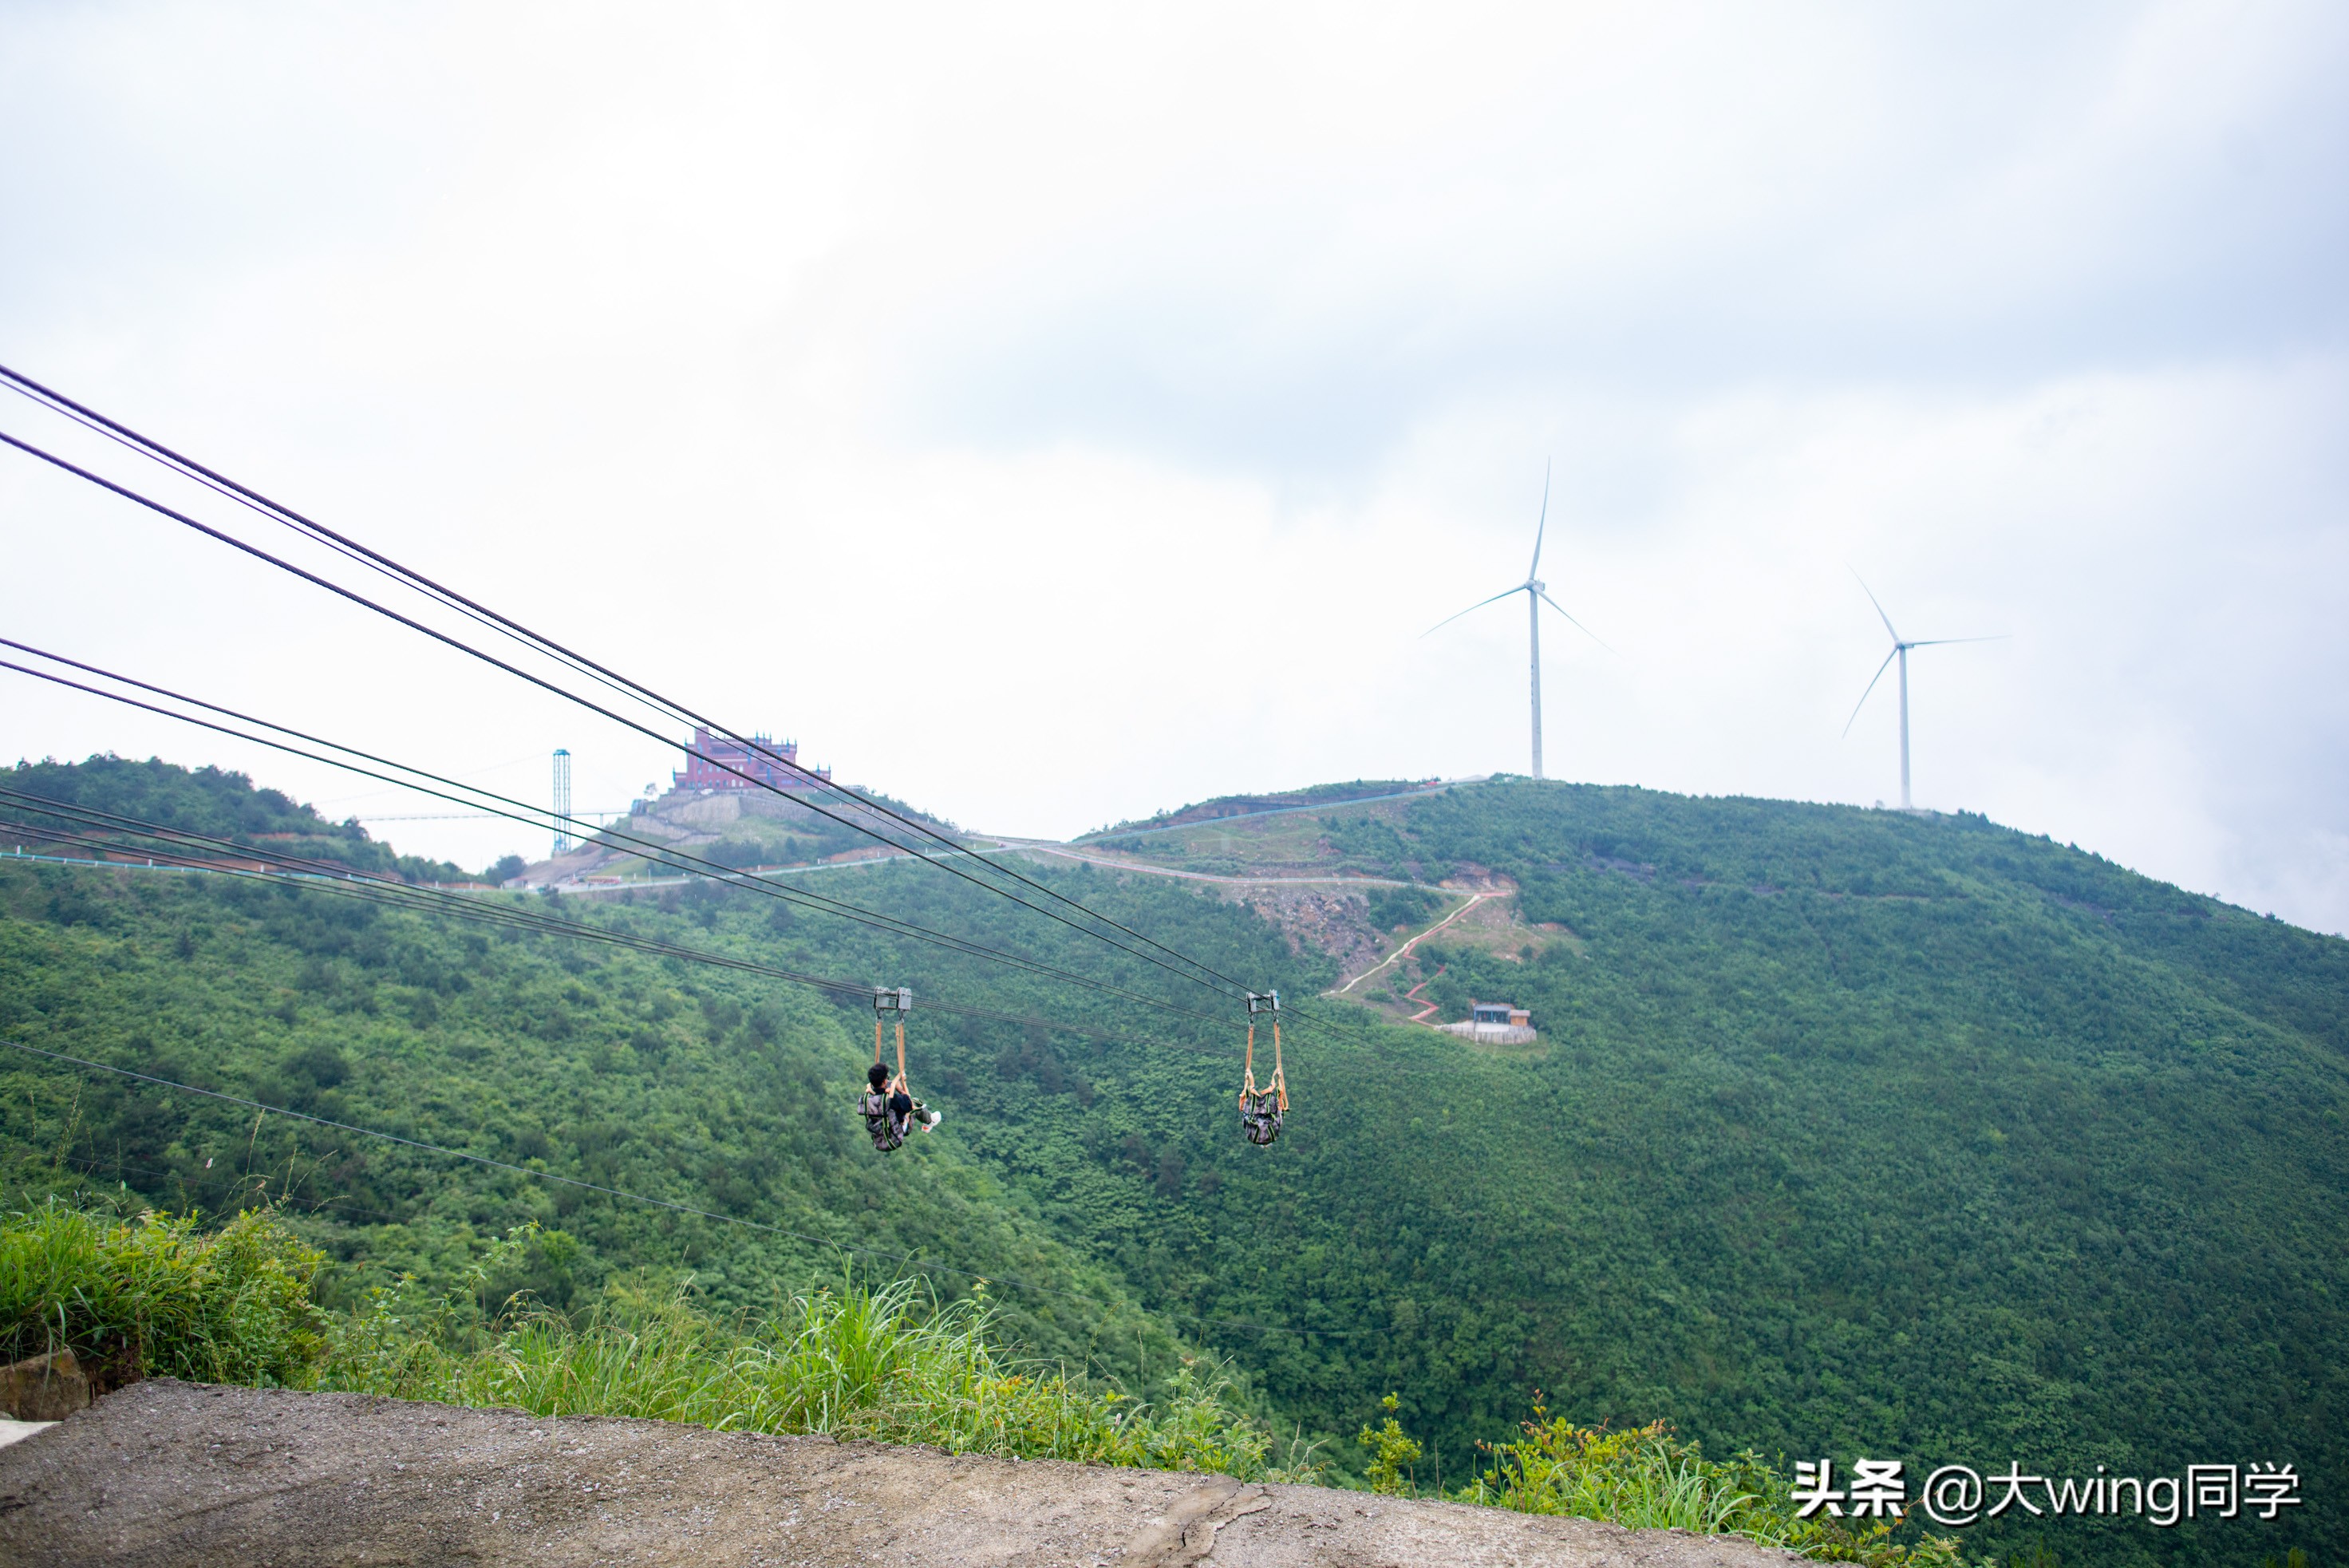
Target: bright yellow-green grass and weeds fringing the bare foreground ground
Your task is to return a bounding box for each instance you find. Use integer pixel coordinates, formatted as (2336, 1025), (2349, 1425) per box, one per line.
(0, 1199), (1961, 1568)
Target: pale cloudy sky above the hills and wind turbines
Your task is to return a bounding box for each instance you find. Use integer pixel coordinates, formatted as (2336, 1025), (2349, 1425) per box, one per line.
(0, 0), (2349, 934)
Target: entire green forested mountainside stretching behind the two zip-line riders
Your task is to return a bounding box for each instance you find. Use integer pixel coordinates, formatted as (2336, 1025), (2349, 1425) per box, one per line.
(0, 761), (2349, 1563)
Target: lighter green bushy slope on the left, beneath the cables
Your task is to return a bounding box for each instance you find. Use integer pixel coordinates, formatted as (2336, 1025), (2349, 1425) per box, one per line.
(0, 865), (1250, 1377)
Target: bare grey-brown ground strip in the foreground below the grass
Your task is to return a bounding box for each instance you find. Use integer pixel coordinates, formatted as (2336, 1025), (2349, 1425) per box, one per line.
(0, 1377), (1802, 1568)
